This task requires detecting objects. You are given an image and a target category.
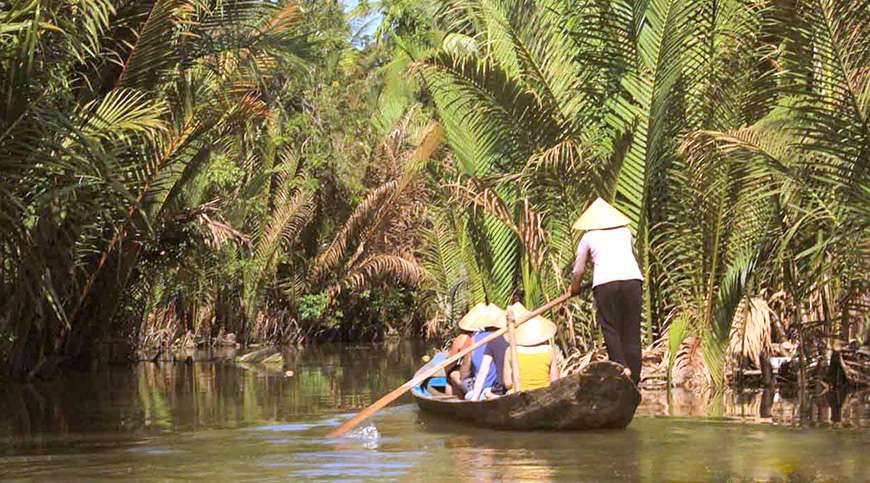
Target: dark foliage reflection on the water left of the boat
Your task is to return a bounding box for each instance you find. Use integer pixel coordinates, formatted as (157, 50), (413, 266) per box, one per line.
(0, 343), (422, 442)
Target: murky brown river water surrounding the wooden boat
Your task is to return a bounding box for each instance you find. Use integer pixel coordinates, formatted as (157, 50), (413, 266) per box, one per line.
(0, 343), (870, 481)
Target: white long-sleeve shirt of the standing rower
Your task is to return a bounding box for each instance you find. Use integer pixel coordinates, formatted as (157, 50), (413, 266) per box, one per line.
(574, 227), (643, 287)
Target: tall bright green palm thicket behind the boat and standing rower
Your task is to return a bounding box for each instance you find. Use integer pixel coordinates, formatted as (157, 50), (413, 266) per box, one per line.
(372, 0), (870, 382)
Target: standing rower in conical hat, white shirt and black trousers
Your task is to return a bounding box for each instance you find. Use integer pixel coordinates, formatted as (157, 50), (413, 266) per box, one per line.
(571, 198), (643, 384)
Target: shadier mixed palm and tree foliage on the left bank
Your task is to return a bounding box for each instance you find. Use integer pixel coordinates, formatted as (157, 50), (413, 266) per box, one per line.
(0, 0), (433, 377)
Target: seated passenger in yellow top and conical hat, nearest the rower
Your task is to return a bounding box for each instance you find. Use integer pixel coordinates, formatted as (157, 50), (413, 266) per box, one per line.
(502, 303), (559, 391)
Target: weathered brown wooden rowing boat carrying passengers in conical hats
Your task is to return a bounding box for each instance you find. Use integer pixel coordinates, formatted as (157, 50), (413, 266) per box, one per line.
(411, 362), (640, 431)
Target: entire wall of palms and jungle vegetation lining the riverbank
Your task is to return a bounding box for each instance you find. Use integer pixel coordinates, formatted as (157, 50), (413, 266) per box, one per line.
(0, 0), (870, 385)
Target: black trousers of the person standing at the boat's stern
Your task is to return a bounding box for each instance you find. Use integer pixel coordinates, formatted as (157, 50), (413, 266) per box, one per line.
(593, 280), (641, 384)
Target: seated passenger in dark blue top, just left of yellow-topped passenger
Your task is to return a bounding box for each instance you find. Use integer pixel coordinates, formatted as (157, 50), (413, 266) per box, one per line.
(465, 304), (508, 401)
